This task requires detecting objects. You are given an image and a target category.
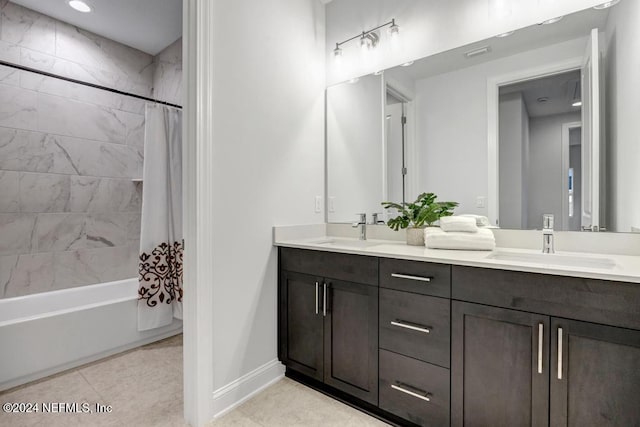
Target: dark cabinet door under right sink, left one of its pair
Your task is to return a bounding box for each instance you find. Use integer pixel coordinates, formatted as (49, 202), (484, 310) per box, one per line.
(451, 301), (549, 427)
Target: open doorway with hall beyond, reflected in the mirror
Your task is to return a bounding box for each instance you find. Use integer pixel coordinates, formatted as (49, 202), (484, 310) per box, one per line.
(498, 70), (582, 231)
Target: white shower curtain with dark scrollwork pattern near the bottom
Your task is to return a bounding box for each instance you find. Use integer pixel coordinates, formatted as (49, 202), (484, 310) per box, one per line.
(138, 104), (183, 331)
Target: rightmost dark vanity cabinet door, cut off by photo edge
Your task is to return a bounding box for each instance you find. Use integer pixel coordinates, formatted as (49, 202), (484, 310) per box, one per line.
(550, 318), (640, 427)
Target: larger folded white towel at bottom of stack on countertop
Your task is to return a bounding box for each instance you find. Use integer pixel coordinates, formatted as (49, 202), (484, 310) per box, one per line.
(424, 227), (496, 251)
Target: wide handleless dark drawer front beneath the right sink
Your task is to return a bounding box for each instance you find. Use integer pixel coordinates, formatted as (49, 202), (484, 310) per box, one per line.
(452, 266), (640, 329)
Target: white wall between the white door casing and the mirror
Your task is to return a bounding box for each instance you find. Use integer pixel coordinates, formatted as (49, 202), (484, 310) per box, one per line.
(209, 0), (325, 412)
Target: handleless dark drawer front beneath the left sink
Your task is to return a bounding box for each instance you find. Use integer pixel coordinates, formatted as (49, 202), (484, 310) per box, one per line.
(280, 248), (378, 286)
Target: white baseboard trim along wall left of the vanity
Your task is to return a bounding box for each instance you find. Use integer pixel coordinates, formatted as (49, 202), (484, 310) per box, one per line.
(213, 359), (284, 419)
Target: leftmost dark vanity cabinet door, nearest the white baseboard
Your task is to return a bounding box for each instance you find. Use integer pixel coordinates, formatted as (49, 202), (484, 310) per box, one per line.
(279, 271), (323, 381)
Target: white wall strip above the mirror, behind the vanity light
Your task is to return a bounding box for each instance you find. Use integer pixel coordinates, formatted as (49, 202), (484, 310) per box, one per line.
(326, 0), (608, 84)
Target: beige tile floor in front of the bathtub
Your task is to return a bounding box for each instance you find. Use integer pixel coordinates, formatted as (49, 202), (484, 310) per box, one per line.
(0, 335), (185, 427)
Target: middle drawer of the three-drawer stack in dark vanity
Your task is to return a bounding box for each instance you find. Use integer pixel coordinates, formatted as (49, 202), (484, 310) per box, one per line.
(380, 289), (451, 368)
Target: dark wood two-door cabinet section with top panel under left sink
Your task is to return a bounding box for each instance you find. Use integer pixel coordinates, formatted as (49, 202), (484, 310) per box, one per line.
(278, 249), (378, 405)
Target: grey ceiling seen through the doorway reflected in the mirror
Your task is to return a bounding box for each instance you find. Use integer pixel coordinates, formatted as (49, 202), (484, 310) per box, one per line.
(500, 70), (581, 117)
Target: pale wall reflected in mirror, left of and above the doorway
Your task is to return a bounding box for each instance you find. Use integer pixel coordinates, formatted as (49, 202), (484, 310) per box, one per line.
(415, 38), (587, 221)
